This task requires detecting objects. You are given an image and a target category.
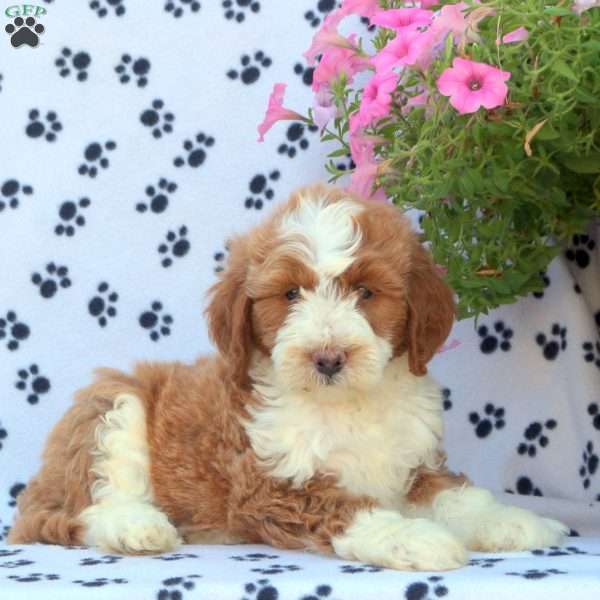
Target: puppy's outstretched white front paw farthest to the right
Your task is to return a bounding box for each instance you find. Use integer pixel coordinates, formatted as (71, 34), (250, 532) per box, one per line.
(467, 505), (569, 552)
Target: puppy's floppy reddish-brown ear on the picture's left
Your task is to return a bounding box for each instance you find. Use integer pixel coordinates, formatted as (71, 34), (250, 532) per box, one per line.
(205, 238), (253, 386)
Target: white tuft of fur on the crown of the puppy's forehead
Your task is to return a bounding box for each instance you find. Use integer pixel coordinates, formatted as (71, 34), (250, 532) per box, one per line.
(280, 192), (363, 277)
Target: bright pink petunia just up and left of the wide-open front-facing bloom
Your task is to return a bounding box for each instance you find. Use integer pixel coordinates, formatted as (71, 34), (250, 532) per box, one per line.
(371, 28), (434, 73)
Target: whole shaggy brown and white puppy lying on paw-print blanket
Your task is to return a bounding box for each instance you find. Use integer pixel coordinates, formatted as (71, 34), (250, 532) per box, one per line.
(10, 186), (567, 570)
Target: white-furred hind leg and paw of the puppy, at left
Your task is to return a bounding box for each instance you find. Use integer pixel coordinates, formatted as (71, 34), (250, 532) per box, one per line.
(80, 393), (181, 554)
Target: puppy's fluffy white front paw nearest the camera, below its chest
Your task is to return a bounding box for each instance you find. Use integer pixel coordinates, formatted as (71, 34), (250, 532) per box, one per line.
(333, 509), (468, 571)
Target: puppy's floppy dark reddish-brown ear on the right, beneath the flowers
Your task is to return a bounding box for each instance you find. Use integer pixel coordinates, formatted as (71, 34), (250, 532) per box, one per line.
(407, 243), (456, 375)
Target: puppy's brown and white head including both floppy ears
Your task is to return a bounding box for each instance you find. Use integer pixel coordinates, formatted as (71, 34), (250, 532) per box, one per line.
(207, 185), (454, 391)
